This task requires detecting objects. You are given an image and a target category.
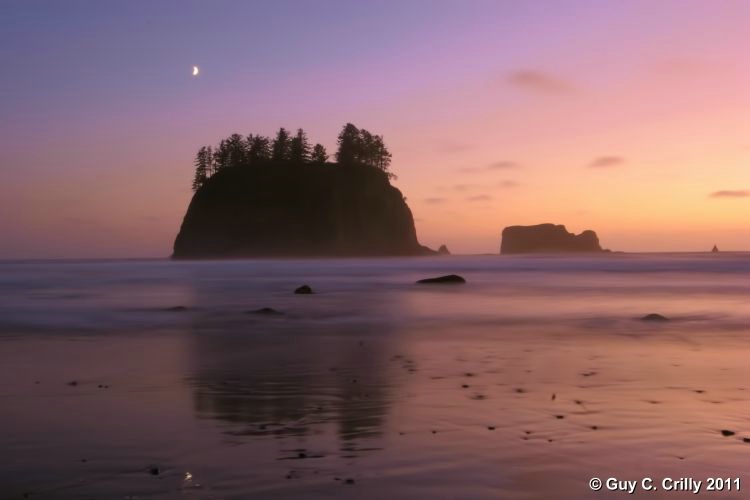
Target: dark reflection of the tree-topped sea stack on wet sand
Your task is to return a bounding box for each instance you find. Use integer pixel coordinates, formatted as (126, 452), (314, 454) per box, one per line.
(190, 308), (395, 455)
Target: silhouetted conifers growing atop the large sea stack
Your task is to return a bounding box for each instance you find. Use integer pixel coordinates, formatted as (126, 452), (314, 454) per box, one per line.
(192, 123), (394, 191)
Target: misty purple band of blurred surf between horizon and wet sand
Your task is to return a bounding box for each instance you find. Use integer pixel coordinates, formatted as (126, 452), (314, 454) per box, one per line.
(0, 253), (750, 335)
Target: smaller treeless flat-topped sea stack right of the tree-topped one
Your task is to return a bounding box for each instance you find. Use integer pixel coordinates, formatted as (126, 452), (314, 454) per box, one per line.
(500, 224), (606, 254)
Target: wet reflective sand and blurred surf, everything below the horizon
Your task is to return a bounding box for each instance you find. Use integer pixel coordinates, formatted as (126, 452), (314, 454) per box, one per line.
(0, 254), (750, 499)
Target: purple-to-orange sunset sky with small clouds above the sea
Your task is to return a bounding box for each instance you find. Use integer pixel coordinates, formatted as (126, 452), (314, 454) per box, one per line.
(0, 0), (750, 259)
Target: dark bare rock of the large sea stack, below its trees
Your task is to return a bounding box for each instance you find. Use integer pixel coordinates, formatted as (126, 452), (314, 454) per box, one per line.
(173, 163), (433, 258)
